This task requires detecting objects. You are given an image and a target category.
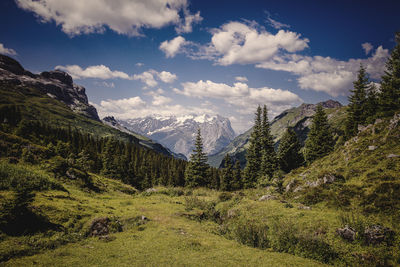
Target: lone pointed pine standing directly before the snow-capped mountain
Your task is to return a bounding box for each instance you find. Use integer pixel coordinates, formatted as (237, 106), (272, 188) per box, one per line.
(185, 129), (209, 187)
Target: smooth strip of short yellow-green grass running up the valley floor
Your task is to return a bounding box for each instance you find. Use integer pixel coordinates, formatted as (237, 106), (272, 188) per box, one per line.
(4, 189), (321, 266)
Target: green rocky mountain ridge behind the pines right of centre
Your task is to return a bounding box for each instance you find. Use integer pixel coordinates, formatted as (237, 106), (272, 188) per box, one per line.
(208, 100), (344, 167)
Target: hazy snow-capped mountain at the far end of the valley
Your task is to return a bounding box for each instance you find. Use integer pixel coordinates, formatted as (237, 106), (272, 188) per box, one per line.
(117, 114), (235, 157)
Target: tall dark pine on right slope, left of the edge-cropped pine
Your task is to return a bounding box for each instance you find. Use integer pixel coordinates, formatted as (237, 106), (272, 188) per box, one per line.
(346, 65), (369, 138)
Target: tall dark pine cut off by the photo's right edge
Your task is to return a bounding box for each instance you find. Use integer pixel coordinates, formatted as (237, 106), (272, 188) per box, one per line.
(379, 32), (400, 117)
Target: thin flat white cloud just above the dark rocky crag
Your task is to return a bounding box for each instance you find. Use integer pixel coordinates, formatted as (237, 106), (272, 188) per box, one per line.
(55, 65), (131, 80)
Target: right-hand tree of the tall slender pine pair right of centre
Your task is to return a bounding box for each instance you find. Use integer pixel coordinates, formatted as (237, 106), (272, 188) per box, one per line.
(260, 105), (277, 179)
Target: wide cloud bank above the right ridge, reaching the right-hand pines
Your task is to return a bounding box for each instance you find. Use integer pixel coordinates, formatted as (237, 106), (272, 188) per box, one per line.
(256, 46), (389, 97)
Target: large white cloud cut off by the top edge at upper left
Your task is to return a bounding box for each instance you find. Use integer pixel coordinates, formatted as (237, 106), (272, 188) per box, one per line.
(16, 0), (201, 36)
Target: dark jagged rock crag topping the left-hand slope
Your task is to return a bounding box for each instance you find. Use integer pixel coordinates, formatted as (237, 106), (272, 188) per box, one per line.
(0, 54), (100, 121)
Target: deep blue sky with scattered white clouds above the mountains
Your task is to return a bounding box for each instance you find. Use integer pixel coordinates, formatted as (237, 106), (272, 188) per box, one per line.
(0, 0), (400, 133)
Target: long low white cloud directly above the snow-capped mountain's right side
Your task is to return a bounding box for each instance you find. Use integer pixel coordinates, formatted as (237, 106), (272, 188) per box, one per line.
(174, 80), (302, 114)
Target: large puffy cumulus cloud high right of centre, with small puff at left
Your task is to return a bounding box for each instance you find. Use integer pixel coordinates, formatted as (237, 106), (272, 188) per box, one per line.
(160, 21), (309, 66)
